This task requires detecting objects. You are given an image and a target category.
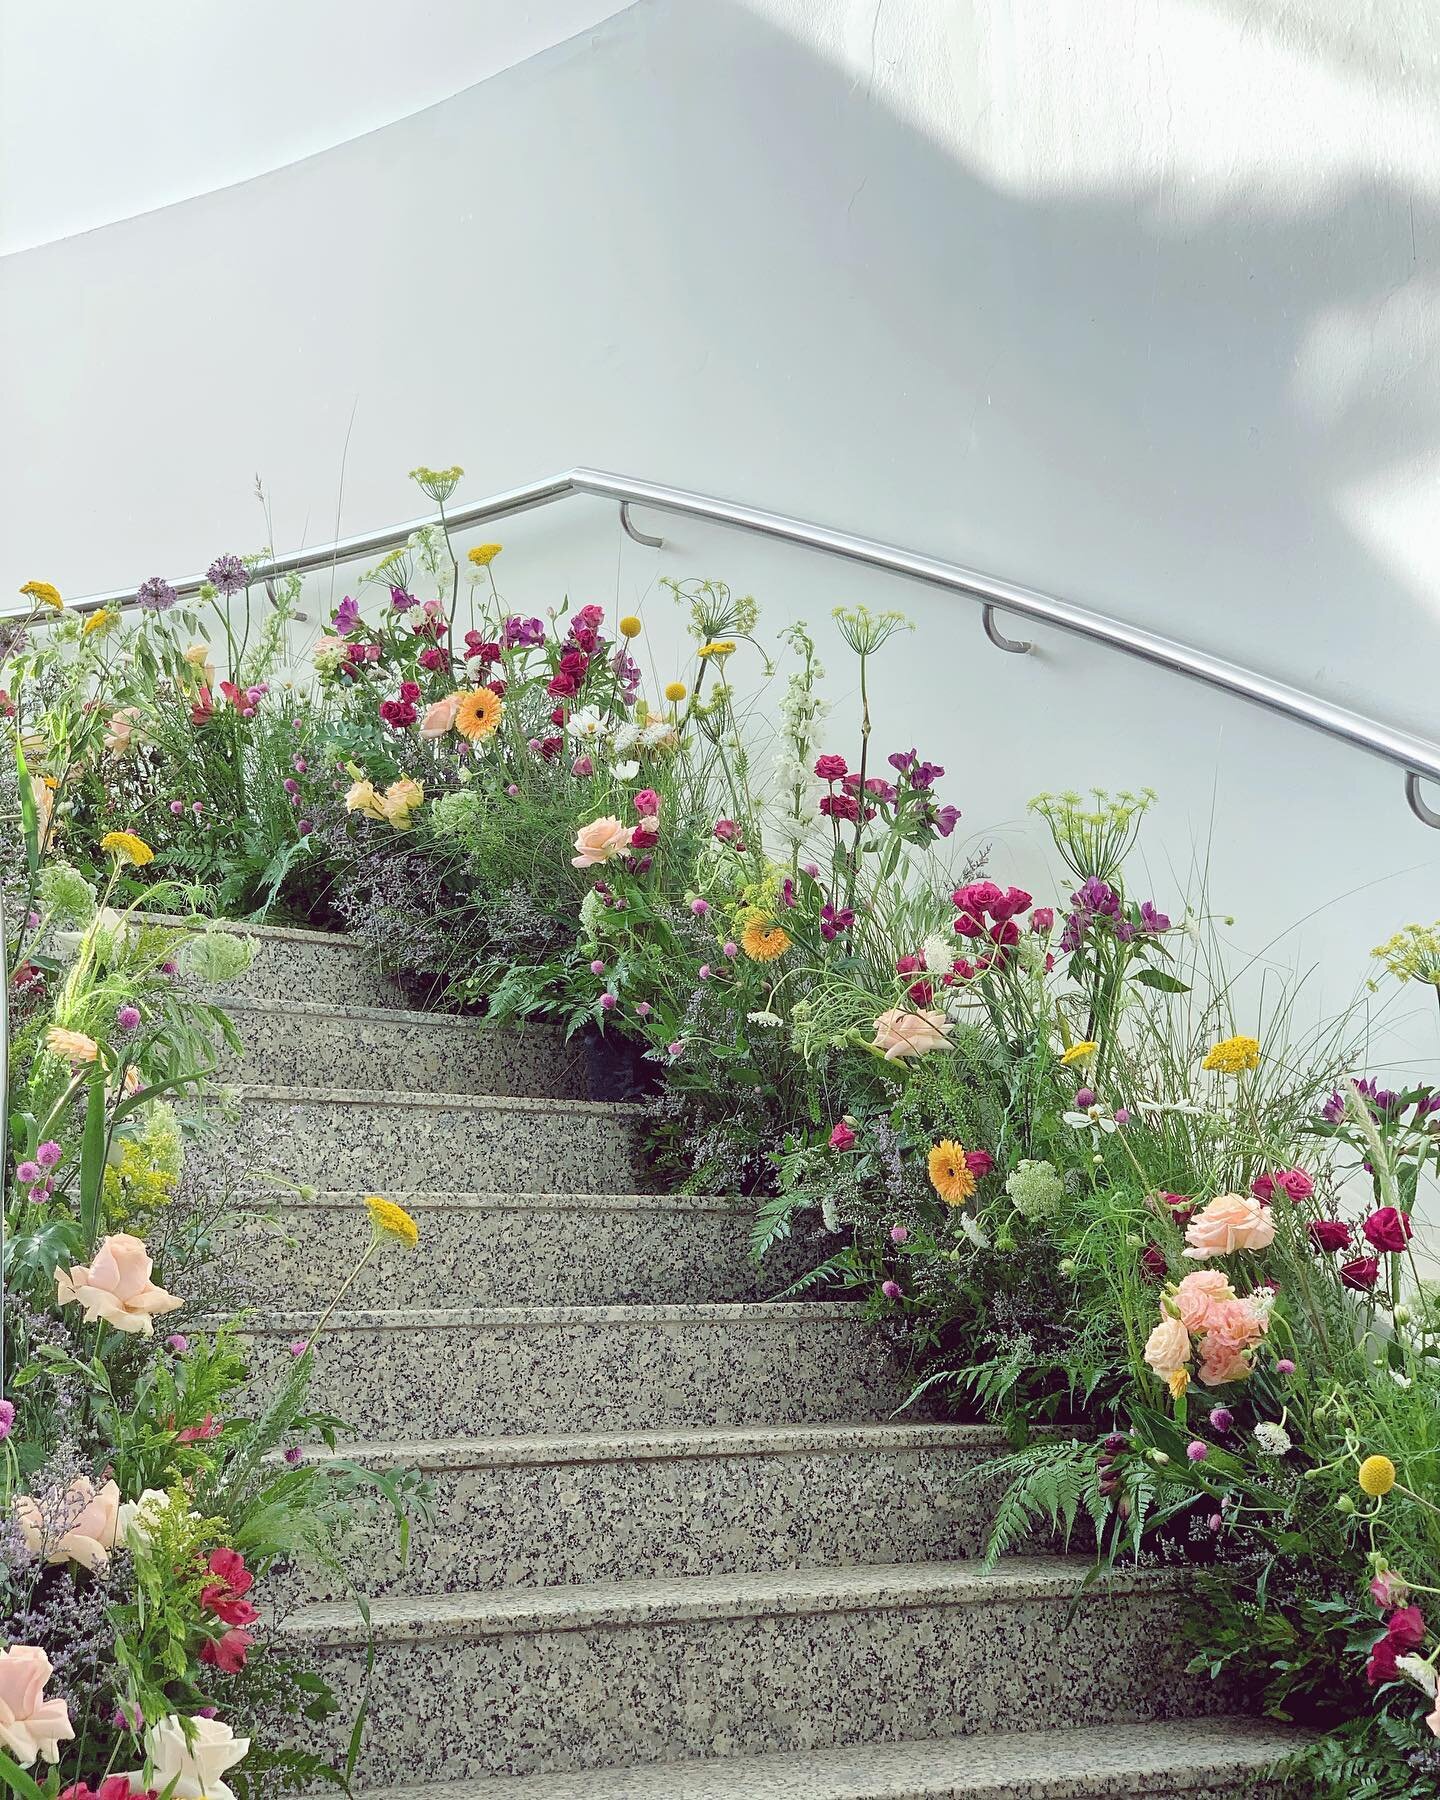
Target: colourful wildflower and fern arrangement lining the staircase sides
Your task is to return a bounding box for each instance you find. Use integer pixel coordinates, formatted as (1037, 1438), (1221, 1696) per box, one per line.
(14, 470), (1440, 1796)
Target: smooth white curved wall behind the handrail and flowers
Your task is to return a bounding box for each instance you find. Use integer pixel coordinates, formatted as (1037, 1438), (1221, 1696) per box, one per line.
(0, 0), (1440, 1073)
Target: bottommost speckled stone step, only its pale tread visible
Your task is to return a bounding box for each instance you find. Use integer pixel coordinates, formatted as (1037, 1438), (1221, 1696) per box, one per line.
(364, 1717), (1309, 1800)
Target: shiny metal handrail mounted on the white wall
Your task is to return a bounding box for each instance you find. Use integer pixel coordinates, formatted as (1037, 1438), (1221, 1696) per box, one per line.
(19, 468), (1440, 828)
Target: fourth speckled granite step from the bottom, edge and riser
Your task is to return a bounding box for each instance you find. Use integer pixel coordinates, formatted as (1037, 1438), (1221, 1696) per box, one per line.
(241, 1285), (907, 1440)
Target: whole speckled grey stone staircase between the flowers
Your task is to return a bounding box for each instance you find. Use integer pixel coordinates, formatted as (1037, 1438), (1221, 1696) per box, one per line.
(194, 927), (1317, 1800)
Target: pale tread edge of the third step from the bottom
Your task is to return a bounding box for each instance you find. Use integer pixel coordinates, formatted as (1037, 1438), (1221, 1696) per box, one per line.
(291, 1420), (1008, 1471)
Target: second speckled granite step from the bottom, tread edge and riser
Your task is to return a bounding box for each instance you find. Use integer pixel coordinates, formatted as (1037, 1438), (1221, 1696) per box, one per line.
(279, 1557), (1222, 1782)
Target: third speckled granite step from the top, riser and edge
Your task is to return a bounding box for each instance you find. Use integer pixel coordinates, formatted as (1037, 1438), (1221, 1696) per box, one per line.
(205, 1087), (648, 1193)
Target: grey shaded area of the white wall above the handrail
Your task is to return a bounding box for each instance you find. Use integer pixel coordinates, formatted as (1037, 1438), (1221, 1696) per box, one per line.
(0, 0), (1440, 752)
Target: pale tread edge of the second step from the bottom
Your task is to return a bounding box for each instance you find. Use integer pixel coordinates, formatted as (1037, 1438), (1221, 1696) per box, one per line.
(281, 1557), (1186, 1643)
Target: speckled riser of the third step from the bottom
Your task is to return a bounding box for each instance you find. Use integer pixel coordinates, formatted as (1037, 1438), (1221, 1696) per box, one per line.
(275, 1445), (1004, 1600)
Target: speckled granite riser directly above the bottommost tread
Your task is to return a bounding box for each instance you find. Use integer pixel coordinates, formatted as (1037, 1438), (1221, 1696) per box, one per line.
(304, 1595), (1220, 1782)
